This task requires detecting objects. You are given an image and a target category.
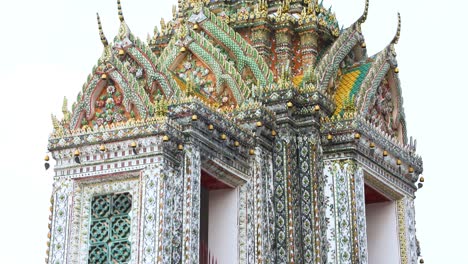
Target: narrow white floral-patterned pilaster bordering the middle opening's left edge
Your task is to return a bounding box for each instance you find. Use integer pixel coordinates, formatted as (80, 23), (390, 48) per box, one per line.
(182, 144), (201, 264)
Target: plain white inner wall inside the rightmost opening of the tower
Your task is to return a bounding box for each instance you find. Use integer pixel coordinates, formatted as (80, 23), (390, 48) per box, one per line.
(366, 201), (400, 264)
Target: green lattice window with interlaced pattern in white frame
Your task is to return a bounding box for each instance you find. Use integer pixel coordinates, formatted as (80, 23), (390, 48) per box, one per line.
(88, 193), (132, 264)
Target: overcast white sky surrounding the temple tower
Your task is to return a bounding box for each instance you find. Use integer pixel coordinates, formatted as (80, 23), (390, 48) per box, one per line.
(0, 0), (462, 264)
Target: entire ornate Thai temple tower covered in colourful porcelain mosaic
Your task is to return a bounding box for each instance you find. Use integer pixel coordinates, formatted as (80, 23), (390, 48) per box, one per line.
(46, 0), (424, 264)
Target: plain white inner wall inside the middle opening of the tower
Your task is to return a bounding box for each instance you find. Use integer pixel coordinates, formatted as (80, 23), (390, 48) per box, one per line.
(208, 189), (238, 264)
